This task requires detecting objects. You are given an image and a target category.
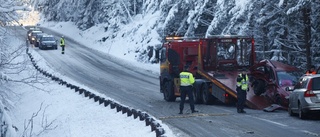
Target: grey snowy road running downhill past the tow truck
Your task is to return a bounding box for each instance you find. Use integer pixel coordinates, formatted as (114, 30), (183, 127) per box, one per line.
(24, 27), (320, 137)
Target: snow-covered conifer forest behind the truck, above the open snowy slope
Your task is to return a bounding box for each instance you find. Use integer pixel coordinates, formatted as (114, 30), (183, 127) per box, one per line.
(25, 0), (320, 68)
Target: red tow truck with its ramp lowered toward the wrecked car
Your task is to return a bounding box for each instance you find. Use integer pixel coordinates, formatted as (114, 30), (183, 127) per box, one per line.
(159, 35), (302, 109)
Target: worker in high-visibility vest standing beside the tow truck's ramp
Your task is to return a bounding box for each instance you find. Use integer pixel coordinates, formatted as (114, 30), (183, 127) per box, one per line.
(236, 70), (249, 113)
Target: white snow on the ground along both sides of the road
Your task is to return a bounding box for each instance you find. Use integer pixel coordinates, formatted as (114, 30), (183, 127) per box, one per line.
(1, 19), (175, 137)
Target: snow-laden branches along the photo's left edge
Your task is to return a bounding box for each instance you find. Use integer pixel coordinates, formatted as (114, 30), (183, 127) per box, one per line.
(0, 0), (31, 137)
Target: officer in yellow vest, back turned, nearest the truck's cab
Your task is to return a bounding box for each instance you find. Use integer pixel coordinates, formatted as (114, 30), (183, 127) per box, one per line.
(179, 66), (198, 114)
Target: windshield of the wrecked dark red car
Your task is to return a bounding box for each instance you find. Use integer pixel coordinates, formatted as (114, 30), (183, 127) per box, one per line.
(277, 71), (301, 86)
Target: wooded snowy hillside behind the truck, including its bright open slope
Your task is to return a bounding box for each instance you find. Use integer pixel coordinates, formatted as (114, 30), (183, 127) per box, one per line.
(31, 0), (320, 66)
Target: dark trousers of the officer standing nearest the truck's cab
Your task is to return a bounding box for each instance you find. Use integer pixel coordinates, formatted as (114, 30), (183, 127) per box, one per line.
(180, 86), (194, 112)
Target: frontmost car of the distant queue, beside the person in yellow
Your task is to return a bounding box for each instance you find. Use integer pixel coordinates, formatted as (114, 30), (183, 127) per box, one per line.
(39, 35), (58, 49)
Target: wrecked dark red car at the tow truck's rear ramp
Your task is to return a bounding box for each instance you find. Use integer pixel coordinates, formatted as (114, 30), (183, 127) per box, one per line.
(250, 60), (303, 107)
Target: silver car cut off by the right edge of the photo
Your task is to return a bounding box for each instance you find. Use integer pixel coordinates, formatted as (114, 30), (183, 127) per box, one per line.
(287, 74), (320, 119)
